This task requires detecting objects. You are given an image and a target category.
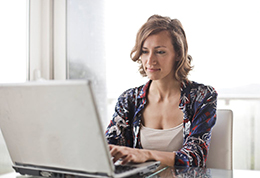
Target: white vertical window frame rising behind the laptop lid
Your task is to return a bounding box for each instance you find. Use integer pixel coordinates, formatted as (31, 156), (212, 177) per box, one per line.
(27, 0), (67, 81)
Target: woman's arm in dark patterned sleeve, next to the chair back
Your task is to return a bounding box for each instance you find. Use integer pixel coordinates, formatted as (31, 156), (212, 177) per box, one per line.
(175, 86), (217, 167)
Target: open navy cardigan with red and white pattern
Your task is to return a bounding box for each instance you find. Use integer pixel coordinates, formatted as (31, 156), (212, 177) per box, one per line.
(106, 81), (217, 167)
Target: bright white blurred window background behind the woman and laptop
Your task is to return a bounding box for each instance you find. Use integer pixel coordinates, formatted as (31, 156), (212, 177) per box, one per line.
(0, 0), (260, 174)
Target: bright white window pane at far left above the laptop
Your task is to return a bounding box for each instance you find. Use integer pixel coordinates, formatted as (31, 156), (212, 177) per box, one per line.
(0, 0), (27, 83)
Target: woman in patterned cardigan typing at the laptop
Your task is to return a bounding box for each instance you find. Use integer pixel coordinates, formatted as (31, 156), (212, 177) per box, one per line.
(106, 15), (217, 167)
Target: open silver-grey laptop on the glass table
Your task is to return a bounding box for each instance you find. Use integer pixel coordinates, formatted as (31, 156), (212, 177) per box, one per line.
(0, 80), (160, 177)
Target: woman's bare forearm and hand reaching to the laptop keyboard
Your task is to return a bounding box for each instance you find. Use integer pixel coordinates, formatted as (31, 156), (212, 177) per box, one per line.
(109, 145), (175, 166)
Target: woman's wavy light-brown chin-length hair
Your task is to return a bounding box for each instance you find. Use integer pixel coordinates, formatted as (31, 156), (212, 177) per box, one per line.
(130, 15), (192, 82)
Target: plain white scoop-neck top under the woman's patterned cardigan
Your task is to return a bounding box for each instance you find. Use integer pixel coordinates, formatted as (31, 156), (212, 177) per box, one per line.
(140, 123), (183, 152)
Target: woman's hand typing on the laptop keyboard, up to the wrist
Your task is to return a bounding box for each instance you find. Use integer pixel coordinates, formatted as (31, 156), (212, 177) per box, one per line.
(109, 145), (151, 164)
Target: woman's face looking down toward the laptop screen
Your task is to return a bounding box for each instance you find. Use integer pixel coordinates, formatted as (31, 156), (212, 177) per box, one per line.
(141, 31), (176, 81)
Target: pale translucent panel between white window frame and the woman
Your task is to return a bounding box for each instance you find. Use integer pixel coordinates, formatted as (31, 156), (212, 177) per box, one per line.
(67, 0), (107, 122)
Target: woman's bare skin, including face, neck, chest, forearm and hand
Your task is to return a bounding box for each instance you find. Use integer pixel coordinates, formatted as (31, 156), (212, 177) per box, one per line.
(109, 31), (183, 166)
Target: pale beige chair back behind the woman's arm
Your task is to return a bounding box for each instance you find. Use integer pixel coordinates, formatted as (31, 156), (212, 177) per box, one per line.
(206, 109), (233, 170)
